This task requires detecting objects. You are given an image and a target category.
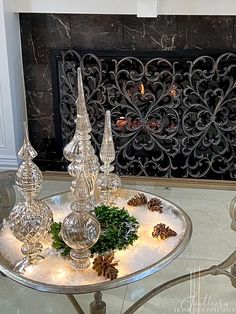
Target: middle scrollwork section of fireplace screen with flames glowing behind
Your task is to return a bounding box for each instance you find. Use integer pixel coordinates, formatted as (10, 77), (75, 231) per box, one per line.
(108, 57), (179, 176)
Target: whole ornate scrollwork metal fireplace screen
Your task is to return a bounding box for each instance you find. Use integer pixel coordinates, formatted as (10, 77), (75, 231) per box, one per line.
(52, 50), (236, 179)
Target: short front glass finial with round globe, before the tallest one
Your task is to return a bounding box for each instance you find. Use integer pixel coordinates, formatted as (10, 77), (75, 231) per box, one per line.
(61, 161), (101, 270)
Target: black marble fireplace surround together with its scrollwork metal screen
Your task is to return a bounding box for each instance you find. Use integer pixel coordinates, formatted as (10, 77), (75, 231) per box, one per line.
(20, 14), (236, 180)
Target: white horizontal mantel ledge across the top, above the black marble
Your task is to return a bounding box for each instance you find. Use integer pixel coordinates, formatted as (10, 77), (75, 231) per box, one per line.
(13, 0), (236, 17)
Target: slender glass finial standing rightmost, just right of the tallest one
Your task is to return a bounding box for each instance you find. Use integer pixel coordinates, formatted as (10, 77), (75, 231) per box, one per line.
(96, 110), (121, 205)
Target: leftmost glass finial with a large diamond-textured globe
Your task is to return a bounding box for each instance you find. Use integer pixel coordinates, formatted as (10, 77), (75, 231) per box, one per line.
(8, 123), (53, 272)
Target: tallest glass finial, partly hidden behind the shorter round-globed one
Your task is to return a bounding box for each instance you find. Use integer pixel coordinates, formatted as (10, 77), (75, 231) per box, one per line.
(63, 68), (99, 210)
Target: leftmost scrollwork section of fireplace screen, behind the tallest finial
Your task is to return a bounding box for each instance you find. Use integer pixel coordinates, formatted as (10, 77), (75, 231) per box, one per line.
(59, 50), (106, 146)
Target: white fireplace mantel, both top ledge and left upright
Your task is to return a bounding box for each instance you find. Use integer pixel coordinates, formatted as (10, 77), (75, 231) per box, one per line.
(0, 0), (236, 169)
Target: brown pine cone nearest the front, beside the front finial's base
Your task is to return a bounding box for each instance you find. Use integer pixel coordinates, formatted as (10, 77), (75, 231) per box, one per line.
(93, 254), (119, 280)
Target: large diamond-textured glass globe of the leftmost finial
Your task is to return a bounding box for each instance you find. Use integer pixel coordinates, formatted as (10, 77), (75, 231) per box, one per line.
(9, 200), (53, 255)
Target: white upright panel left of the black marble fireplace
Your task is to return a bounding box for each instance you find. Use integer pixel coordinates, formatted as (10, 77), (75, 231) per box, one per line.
(0, 0), (26, 169)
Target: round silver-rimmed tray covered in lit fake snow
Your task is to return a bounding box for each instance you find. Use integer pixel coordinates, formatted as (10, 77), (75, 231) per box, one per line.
(0, 189), (192, 294)
